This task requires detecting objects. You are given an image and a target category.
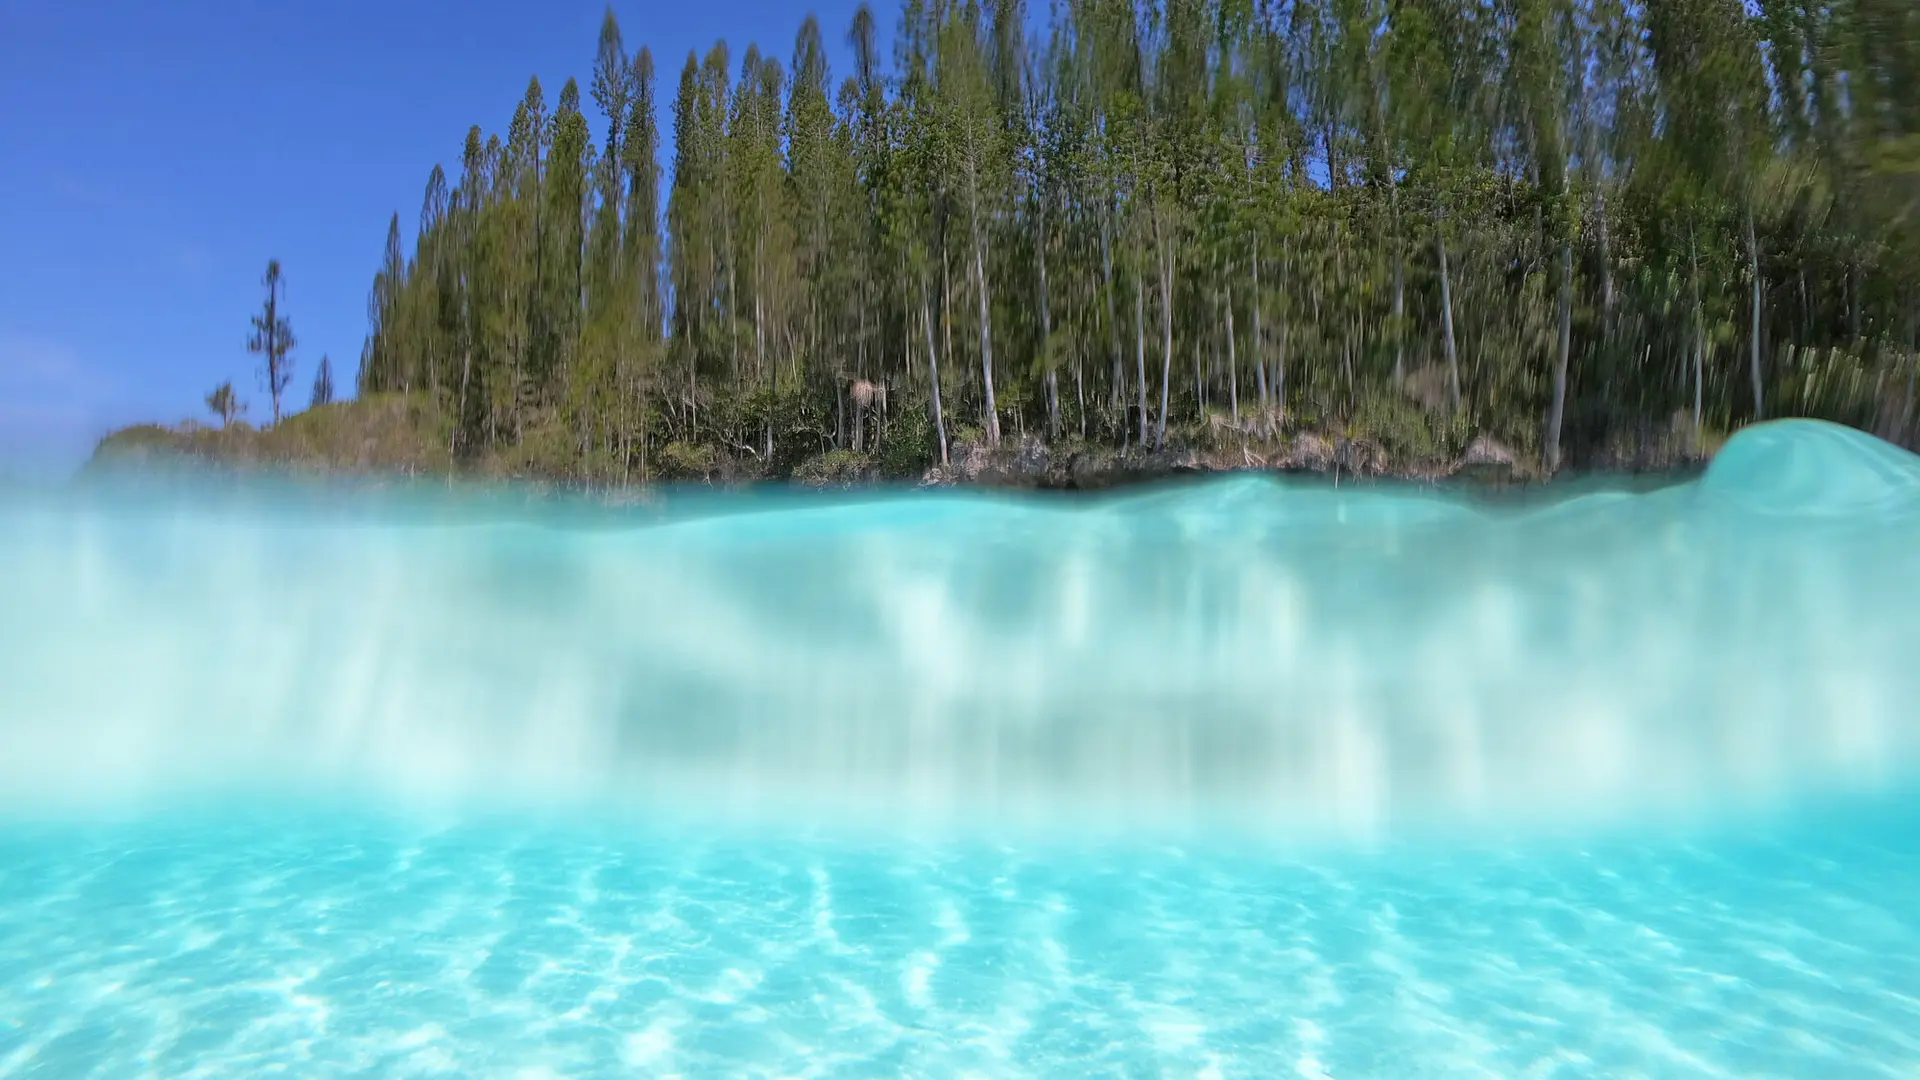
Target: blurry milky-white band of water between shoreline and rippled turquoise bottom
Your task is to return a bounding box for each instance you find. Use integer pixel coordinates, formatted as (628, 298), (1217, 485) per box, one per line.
(0, 421), (1920, 834)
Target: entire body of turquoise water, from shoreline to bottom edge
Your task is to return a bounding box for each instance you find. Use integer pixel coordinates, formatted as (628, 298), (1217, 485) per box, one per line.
(0, 423), (1920, 1078)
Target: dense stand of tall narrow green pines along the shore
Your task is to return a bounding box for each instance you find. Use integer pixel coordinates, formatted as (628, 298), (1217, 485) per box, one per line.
(359, 0), (1920, 479)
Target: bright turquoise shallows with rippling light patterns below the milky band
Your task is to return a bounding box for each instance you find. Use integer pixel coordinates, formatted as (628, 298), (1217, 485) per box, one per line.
(0, 801), (1920, 1078)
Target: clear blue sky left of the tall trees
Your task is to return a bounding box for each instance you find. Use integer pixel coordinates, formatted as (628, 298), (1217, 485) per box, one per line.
(0, 0), (864, 475)
